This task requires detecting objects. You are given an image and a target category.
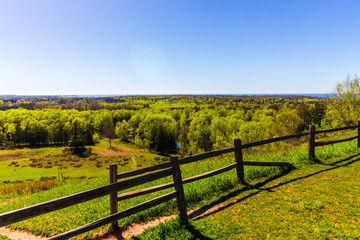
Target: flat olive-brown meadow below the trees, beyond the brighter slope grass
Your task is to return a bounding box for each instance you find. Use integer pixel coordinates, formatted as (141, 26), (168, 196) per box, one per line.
(0, 140), (168, 188)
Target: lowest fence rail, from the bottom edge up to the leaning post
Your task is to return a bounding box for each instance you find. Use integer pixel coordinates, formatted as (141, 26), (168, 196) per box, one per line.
(48, 191), (176, 240)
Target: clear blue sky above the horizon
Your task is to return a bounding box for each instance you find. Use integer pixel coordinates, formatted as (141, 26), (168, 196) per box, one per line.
(0, 0), (360, 95)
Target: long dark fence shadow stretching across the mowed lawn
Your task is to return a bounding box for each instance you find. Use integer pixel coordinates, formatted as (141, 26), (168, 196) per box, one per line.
(188, 154), (360, 220)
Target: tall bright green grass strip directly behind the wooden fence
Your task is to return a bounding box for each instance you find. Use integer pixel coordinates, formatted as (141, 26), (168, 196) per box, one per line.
(0, 131), (357, 239)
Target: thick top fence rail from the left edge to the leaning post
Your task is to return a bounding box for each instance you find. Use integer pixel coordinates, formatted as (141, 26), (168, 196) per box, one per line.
(0, 168), (173, 226)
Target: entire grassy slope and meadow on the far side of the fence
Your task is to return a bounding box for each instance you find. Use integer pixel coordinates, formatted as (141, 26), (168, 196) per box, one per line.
(0, 130), (357, 239)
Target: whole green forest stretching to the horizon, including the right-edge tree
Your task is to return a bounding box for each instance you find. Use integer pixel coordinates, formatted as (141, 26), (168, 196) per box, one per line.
(0, 78), (360, 156)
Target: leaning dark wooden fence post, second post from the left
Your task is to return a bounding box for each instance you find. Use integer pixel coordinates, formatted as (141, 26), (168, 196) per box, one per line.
(170, 156), (188, 224)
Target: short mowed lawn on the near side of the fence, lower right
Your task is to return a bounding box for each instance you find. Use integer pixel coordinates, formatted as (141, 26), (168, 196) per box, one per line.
(136, 154), (360, 239)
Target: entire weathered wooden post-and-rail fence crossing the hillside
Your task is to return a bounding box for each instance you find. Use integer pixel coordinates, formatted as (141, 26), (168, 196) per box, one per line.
(0, 121), (360, 239)
